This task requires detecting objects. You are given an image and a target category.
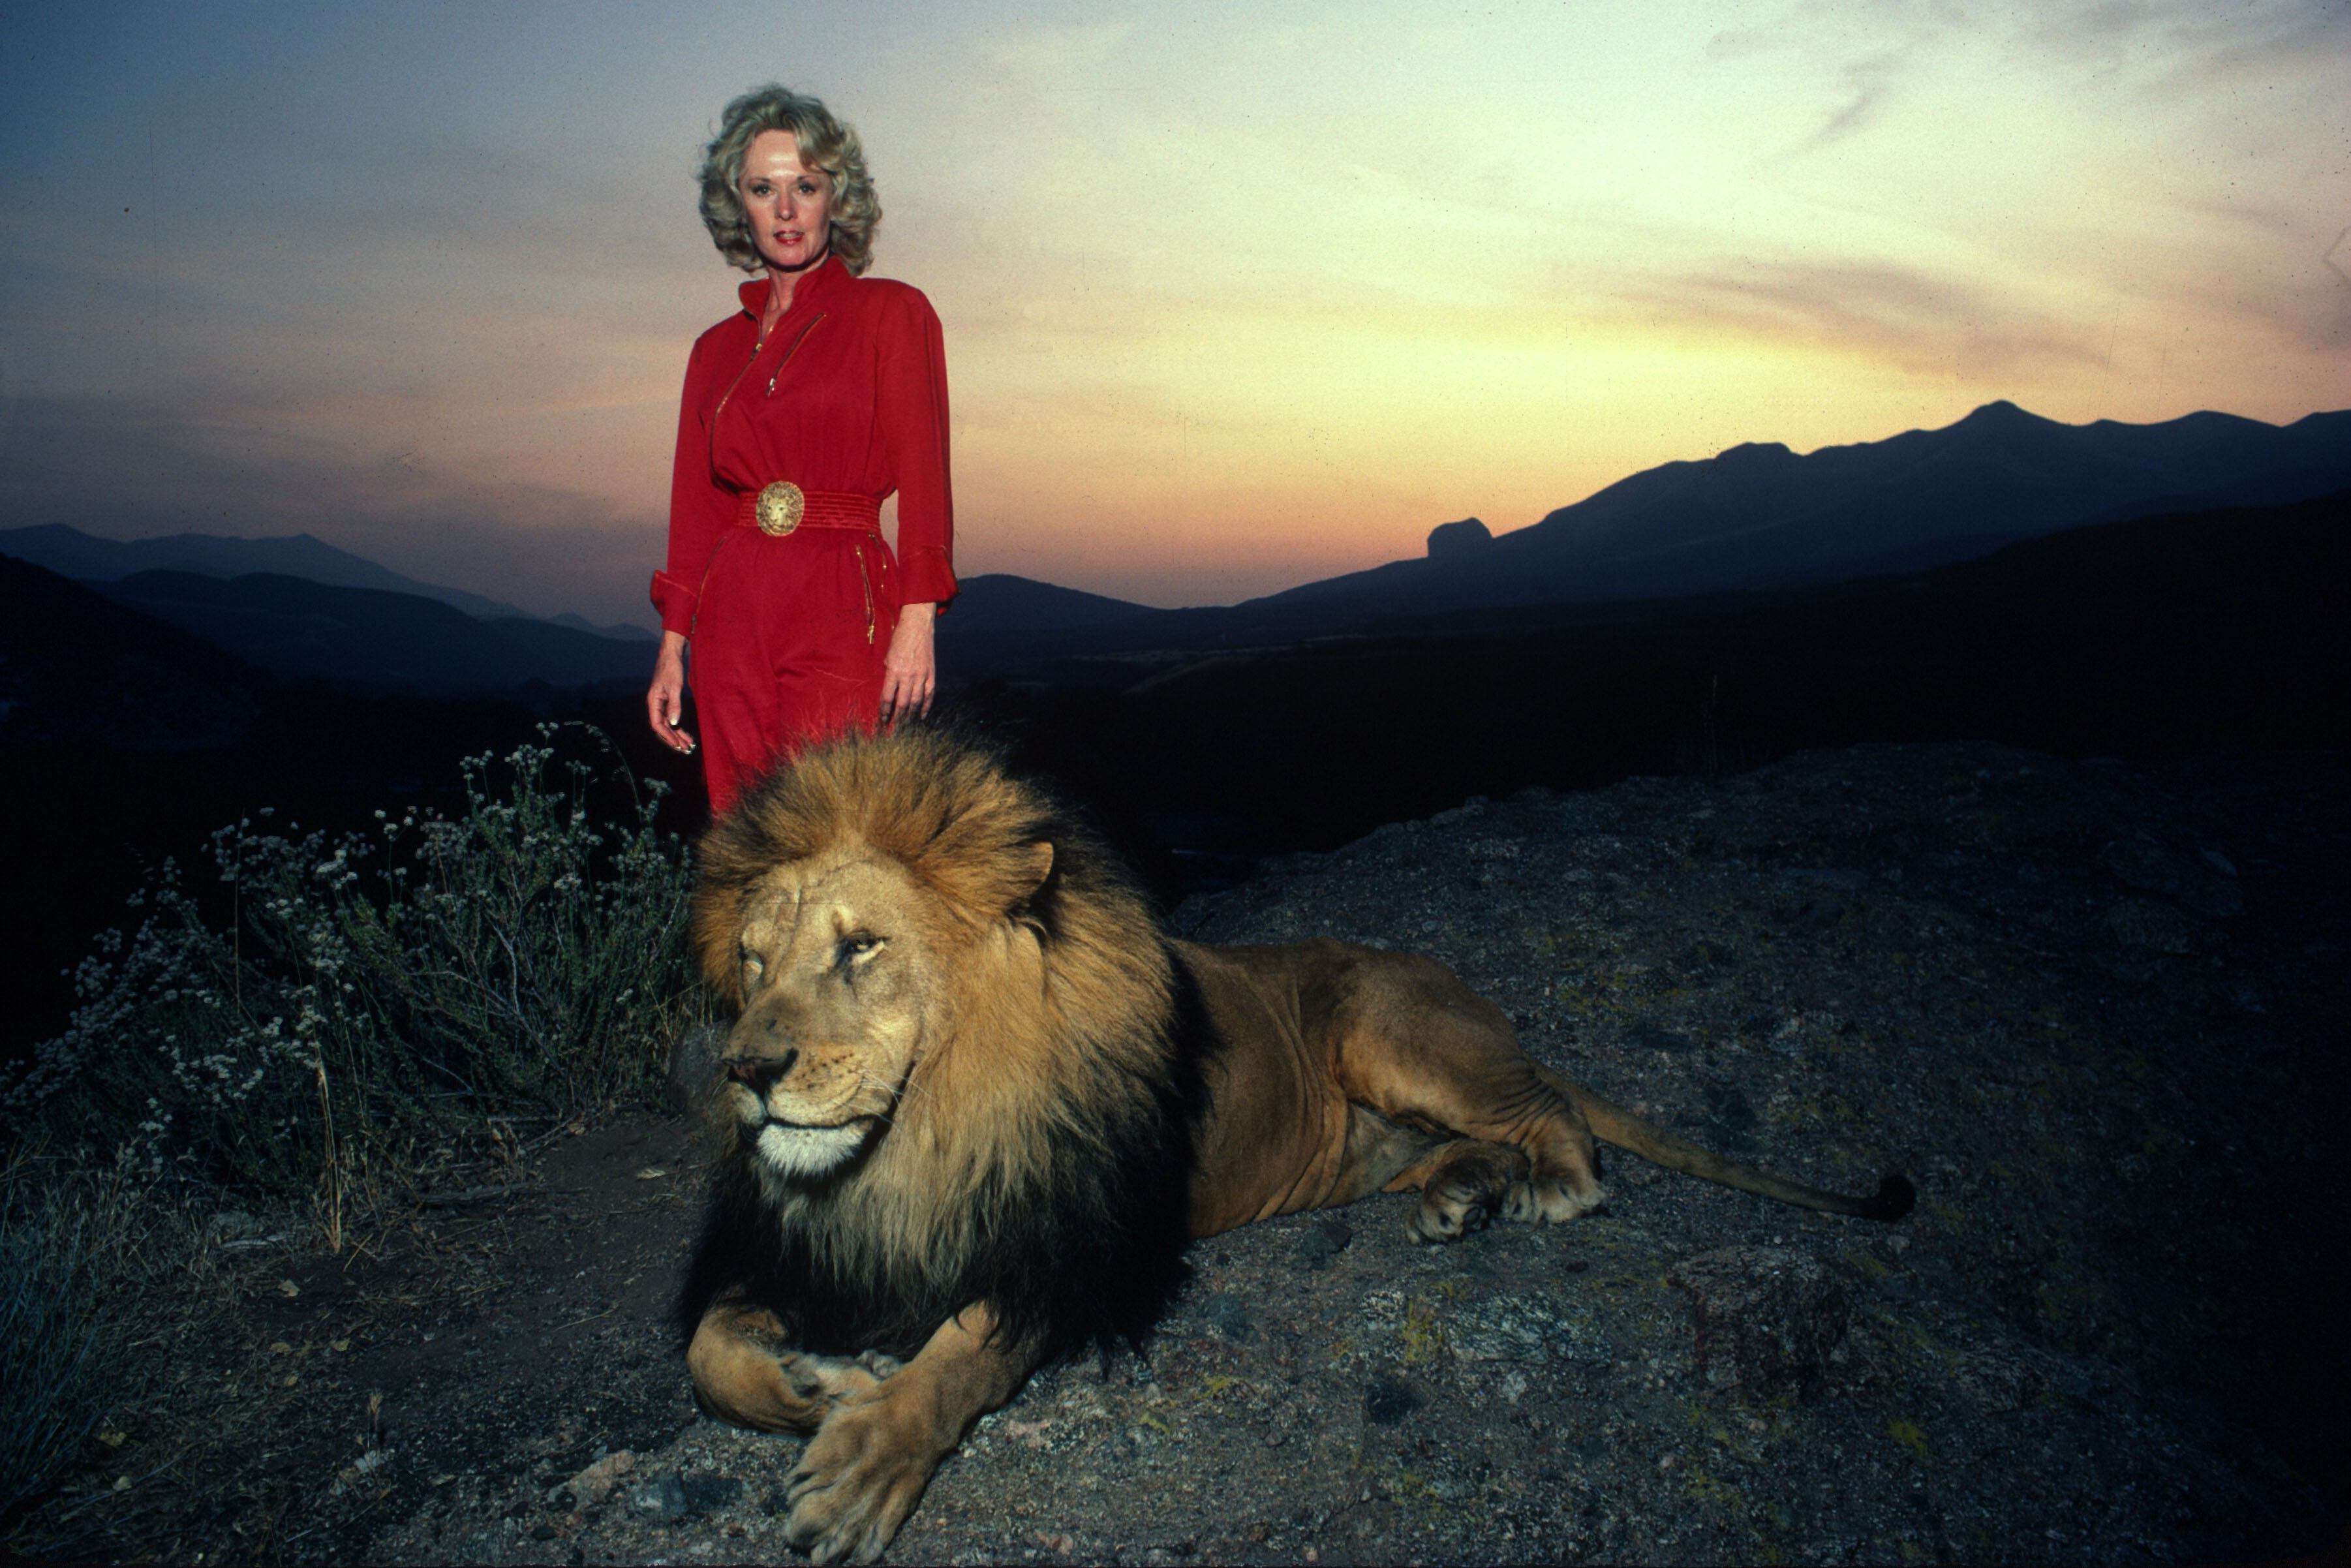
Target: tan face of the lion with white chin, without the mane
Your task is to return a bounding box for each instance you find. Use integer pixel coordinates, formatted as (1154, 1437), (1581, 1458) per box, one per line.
(720, 858), (952, 1180)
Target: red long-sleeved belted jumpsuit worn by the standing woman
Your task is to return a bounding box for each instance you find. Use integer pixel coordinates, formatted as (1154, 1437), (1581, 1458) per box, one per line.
(654, 256), (955, 816)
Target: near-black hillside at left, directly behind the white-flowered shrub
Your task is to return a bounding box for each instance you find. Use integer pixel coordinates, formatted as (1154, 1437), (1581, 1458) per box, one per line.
(0, 557), (703, 1069)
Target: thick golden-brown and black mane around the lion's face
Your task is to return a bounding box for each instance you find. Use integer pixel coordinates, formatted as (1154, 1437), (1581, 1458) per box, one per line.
(677, 726), (1206, 1357)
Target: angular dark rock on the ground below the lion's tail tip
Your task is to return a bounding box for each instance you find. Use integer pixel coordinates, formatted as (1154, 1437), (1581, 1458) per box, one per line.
(1667, 1246), (1852, 1399)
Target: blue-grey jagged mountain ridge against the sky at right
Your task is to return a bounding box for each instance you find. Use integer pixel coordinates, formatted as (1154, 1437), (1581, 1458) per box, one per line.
(1237, 402), (2351, 619)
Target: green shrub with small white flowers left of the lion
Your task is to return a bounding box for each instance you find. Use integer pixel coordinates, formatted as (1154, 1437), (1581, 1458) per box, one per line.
(0, 724), (691, 1192)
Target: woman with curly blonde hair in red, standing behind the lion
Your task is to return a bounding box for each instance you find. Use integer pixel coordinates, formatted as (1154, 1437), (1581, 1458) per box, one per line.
(644, 87), (955, 816)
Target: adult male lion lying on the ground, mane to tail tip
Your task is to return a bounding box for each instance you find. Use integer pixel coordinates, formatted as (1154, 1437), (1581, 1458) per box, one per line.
(679, 729), (1909, 1561)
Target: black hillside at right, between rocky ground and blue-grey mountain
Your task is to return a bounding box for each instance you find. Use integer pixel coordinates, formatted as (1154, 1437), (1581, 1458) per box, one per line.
(950, 491), (2351, 865)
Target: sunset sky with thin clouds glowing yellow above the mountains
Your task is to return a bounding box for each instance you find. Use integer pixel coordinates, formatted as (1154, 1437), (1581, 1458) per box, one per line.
(0, 0), (2351, 623)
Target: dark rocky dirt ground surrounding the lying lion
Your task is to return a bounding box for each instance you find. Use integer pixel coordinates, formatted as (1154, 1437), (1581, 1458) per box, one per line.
(19, 745), (2351, 1563)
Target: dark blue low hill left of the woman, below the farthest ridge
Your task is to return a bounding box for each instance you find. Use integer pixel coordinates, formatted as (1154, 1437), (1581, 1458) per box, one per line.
(97, 571), (651, 696)
